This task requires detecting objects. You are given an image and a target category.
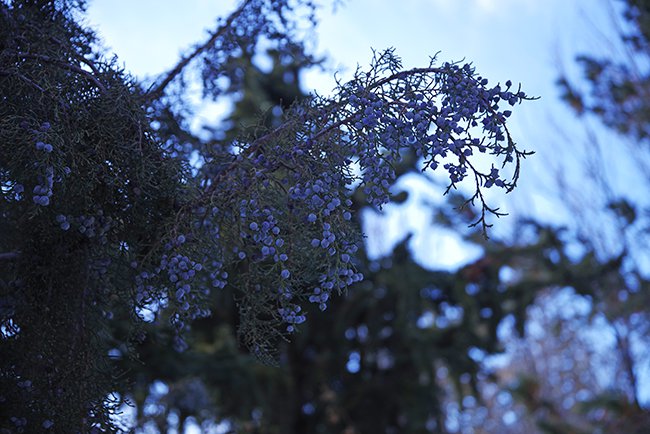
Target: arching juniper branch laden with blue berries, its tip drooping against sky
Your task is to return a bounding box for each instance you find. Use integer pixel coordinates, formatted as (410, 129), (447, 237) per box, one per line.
(147, 50), (529, 346)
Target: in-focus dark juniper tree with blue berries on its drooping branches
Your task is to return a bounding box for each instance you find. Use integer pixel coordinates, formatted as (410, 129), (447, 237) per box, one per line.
(0, 0), (527, 432)
